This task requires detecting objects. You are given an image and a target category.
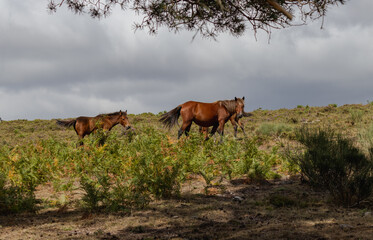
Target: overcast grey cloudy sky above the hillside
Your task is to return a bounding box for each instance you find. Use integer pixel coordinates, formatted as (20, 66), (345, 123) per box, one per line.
(0, 0), (373, 120)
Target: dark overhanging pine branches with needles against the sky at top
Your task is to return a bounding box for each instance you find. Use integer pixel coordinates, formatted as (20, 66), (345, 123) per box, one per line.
(48, 0), (345, 38)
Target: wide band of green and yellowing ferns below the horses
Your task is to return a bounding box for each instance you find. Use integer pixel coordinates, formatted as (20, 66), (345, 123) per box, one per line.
(0, 121), (279, 213)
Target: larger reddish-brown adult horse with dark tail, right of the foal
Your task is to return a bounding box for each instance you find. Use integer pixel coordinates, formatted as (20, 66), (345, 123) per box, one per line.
(159, 97), (245, 140)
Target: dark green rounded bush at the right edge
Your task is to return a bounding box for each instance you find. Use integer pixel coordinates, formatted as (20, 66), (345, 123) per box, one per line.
(289, 128), (373, 206)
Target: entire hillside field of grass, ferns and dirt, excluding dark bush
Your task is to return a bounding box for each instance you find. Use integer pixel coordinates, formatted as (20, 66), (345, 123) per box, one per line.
(0, 103), (373, 239)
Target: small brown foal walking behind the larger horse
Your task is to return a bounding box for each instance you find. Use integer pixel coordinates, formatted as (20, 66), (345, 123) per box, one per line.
(57, 110), (131, 140)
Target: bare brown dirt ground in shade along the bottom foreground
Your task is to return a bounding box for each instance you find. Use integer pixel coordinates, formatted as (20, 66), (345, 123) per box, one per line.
(0, 179), (373, 240)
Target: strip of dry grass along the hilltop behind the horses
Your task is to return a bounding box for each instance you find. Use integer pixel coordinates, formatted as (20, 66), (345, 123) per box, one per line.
(0, 104), (373, 145)
